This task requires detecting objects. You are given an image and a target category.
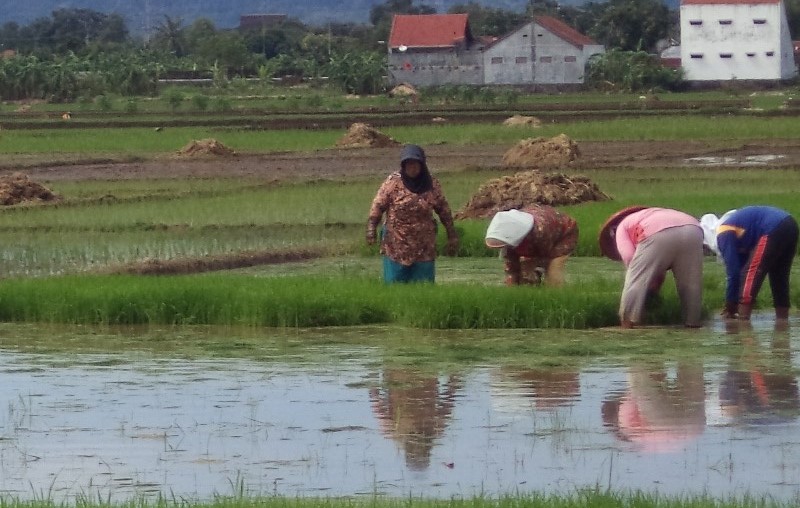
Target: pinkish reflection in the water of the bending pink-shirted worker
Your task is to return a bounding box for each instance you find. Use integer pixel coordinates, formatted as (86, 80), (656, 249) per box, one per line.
(602, 362), (706, 452)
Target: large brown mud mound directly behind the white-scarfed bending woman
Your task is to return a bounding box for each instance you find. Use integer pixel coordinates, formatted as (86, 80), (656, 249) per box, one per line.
(455, 171), (610, 219)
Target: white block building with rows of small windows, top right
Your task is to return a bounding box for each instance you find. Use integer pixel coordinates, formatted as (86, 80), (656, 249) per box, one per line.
(681, 0), (797, 81)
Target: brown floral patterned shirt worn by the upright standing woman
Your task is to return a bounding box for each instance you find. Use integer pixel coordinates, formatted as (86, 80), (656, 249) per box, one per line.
(367, 171), (456, 266)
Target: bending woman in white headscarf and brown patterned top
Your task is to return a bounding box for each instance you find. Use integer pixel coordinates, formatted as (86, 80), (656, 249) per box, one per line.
(486, 205), (578, 286)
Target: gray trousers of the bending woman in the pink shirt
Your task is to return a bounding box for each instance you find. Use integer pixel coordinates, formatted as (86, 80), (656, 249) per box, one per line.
(619, 225), (703, 326)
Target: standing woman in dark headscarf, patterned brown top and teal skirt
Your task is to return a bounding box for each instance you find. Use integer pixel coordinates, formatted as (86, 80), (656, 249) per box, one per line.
(367, 145), (458, 283)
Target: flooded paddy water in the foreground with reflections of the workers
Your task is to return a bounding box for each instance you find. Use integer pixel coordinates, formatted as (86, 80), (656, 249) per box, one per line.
(0, 316), (800, 502)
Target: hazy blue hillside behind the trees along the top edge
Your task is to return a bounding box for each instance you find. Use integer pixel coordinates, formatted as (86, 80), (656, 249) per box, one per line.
(0, 0), (530, 34)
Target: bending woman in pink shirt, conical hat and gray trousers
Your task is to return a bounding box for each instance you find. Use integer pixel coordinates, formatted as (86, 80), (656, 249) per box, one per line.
(599, 206), (703, 328)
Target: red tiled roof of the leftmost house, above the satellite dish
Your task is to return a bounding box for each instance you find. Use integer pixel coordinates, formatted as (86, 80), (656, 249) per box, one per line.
(389, 14), (472, 48)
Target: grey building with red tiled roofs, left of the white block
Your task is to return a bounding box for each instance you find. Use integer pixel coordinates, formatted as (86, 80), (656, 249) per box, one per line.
(388, 14), (604, 86)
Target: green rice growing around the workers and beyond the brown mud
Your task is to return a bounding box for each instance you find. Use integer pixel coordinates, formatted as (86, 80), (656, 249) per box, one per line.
(0, 111), (800, 328)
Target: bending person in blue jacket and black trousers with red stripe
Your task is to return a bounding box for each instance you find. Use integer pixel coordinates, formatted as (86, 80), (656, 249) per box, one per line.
(709, 206), (798, 320)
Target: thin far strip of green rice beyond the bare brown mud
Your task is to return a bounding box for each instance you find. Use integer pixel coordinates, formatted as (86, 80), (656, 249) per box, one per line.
(0, 115), (800, 155)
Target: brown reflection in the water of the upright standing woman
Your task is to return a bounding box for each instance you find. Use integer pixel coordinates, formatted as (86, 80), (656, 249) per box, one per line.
(370, 369), (461, 470)
